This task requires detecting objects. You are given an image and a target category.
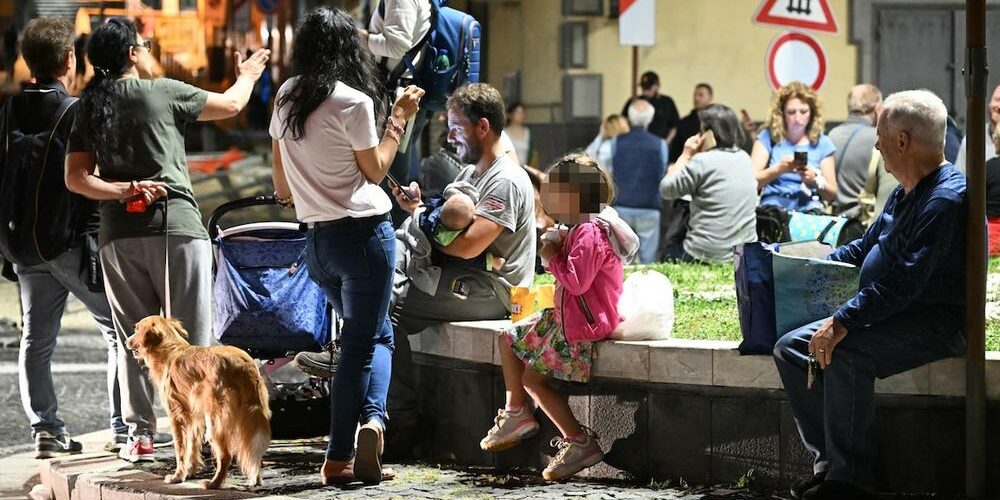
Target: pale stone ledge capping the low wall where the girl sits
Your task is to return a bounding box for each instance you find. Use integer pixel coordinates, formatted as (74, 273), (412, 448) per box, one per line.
(410, 320), (1000, 400)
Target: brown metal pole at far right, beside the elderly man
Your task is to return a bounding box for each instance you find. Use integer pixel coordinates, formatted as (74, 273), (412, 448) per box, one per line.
(965, 0), (987, 498)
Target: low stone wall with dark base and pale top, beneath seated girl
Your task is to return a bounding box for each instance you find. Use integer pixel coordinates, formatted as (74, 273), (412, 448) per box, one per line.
(411, 324), (1000, 493)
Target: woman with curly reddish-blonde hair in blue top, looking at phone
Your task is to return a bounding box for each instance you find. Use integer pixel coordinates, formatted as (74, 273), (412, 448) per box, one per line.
(750, 82), (837, 213)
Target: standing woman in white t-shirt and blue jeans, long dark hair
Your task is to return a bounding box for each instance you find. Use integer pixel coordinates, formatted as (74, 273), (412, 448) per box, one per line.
(270, 8), (423, 484)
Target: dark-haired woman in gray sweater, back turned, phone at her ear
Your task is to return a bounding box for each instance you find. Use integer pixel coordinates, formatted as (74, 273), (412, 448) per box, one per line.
(660, 104), (757, 262)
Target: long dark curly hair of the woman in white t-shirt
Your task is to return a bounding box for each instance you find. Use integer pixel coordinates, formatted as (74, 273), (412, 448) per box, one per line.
(277, 7), (388, 141)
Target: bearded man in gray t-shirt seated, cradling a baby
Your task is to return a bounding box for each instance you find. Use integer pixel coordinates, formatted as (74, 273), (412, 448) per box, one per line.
(386, 83), (535, 459)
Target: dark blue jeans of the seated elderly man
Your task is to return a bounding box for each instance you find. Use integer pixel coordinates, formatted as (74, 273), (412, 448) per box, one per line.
(774, 314), (965, 486)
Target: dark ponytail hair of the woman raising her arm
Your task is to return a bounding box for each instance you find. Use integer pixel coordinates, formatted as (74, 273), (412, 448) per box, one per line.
(79, 17), (137, 162)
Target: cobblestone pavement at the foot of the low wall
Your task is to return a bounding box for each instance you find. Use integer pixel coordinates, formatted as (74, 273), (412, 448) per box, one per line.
(133, 439), (783, 500)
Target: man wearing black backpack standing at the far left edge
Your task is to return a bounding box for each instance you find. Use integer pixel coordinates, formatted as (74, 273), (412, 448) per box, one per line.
(0, 17), (126, 458)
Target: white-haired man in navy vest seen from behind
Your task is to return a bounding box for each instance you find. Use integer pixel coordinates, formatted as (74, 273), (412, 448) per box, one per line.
(611, 99), (670, 264)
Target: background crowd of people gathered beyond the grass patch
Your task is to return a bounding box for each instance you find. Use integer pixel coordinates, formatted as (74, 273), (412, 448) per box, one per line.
(585, 72), (1000, 263)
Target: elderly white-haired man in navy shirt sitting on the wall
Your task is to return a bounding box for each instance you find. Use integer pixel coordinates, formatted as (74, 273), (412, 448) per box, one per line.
(774, 90), (967, 499)
